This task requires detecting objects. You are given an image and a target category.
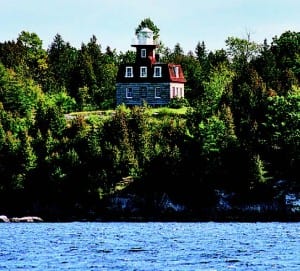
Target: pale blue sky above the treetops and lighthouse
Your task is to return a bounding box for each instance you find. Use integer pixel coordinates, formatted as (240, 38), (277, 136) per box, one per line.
(0, 0), (300, 53)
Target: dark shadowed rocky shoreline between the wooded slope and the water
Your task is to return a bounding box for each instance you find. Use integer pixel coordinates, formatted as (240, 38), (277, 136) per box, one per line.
(0, 191), (300, 223)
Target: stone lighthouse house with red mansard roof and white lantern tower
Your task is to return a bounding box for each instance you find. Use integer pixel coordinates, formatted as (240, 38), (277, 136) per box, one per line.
(116, 28), (185, 106)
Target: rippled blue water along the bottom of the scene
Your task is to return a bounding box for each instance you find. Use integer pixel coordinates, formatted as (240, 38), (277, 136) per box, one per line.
(0, 222), (300, 271)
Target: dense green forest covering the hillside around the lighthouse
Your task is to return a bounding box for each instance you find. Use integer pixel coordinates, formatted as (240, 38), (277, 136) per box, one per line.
(0, 21), (300, 219)
